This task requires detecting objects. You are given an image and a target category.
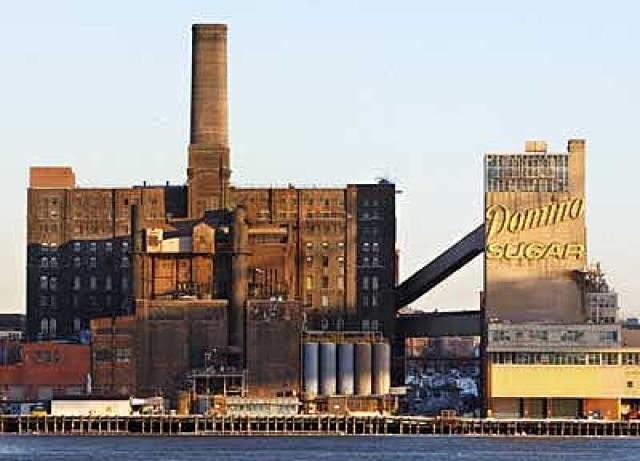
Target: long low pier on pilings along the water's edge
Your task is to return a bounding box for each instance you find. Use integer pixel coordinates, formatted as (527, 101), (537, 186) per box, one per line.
(0, 415), (640, 437)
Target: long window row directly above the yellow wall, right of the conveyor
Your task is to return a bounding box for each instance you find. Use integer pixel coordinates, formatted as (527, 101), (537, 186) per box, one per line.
(490, 352), (624, 365)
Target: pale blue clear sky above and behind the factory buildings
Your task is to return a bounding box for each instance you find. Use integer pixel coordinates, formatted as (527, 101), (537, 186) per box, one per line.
(0, 0), (640, 315)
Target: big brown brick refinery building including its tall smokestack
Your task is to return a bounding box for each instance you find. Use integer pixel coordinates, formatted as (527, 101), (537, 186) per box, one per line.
(27, 24), (396, 339)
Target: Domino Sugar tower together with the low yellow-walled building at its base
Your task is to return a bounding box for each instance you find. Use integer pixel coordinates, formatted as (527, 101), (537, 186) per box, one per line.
(483, 140), (640, 419)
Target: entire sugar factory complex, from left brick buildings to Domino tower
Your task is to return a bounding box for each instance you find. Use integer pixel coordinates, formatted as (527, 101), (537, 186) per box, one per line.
(0, 24), (640, 420)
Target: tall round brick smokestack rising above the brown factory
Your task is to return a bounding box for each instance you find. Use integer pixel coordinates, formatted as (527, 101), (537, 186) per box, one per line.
(187, 24), (230, 218)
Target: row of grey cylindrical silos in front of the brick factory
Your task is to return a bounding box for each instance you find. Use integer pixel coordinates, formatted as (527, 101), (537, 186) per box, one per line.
(302, 341), (391, 398)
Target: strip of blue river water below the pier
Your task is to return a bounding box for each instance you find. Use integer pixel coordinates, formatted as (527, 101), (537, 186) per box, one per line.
(0, 436), (640, 461)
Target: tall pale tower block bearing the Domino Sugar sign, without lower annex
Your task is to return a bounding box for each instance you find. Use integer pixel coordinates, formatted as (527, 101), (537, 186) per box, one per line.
(484, 140), (587, 322)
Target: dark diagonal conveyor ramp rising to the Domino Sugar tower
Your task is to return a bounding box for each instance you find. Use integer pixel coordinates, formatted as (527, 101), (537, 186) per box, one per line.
(395, 224), (484, 310)
